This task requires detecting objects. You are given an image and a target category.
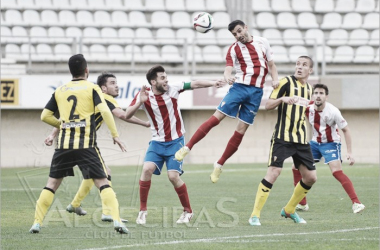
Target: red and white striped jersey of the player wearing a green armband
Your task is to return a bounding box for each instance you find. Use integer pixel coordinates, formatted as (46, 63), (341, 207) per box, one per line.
(129, 82), (185, 142)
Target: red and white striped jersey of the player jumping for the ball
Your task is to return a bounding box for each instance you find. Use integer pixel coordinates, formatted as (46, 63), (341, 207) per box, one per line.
(226, 36), (273, 88)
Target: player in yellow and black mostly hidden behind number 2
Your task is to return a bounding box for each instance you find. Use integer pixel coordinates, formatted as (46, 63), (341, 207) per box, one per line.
(45, 72), (150, 222)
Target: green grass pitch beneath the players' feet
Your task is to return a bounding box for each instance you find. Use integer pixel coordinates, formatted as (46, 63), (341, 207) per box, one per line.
(1, 163), (379, 250)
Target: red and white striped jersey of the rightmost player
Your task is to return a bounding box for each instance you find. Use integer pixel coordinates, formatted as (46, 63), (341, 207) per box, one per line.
(306, 102), (348, 143)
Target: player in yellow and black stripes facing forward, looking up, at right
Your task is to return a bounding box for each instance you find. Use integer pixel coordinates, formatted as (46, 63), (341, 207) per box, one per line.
(248, 56), (317, 226)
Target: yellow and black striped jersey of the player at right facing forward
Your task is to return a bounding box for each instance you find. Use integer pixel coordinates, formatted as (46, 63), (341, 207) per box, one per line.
(270, 76), (312, 144)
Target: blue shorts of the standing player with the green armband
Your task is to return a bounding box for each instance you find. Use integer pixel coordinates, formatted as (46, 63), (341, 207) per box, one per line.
(144, 136), (185, 175)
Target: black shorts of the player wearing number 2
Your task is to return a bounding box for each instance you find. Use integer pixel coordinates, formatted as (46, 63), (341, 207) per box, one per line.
(49, 148), (107, 179)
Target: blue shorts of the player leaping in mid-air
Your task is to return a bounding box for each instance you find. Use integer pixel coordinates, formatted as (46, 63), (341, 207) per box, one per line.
(217, 82), (263, 125)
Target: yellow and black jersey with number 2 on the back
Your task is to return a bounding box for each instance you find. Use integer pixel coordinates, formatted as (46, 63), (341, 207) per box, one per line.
(41, 80), (118, 149)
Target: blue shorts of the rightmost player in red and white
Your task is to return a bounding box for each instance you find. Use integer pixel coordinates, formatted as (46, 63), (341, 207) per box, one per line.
(310, 141), (342, 164)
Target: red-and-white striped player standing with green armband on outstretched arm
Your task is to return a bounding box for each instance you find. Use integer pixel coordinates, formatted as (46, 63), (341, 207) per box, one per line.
(127, 65), (224, 224)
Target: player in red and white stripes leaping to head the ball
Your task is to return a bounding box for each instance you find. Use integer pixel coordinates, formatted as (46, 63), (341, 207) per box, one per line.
(175, 20), (278, 183)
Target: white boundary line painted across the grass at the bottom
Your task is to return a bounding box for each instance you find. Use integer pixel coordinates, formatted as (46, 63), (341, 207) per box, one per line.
(83, 227), (380, 250)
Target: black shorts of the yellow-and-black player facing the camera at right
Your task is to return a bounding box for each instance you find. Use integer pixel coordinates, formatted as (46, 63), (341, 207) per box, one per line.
(269, 139), (315, 170)
